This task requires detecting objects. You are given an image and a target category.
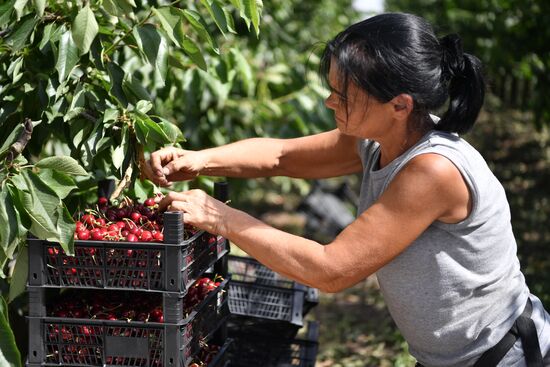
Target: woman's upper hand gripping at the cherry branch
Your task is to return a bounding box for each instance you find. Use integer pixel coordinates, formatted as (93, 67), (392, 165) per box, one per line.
(145, 147), (205, 186)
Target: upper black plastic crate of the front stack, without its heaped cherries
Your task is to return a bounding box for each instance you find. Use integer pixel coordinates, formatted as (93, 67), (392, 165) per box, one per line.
(28, 212), (227, 293)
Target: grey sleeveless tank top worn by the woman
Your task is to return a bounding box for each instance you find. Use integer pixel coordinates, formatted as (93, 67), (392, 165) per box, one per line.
(358, 131), (549, 367)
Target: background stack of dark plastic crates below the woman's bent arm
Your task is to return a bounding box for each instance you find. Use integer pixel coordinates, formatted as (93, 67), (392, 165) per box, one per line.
(228, 256), (319, 367)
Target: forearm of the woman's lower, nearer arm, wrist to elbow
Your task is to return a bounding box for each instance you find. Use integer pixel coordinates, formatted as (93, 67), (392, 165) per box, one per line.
(221, 209), (336, 292)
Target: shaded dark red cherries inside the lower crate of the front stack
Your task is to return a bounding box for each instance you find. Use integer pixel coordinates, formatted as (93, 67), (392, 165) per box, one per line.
(48, 276), (223, 323)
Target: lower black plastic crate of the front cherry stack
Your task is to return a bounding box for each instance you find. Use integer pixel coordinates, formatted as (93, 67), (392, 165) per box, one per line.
(27, 279), (229, 367)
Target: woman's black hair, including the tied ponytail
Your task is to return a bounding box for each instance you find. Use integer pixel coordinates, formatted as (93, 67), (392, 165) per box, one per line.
(320, 13), (485, 133)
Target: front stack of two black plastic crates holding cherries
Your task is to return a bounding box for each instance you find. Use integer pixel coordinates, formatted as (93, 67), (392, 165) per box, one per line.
(27, 186), (229, 367)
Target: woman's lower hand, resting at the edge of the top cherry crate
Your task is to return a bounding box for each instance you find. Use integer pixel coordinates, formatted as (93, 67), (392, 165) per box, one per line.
(159, 190), (235, 236)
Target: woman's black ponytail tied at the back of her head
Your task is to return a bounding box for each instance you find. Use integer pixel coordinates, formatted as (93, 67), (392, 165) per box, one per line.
(435, 34), (485, 134)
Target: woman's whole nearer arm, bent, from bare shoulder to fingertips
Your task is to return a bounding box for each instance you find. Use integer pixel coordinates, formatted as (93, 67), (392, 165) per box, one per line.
(157, 154), (470, 292)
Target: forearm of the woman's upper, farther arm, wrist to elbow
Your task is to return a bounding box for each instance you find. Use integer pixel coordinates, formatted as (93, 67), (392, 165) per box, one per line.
(200, 138), (282, 178)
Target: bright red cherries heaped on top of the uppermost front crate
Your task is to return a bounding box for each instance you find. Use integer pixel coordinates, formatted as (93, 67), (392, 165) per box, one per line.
(74, 197), (164, 242)
